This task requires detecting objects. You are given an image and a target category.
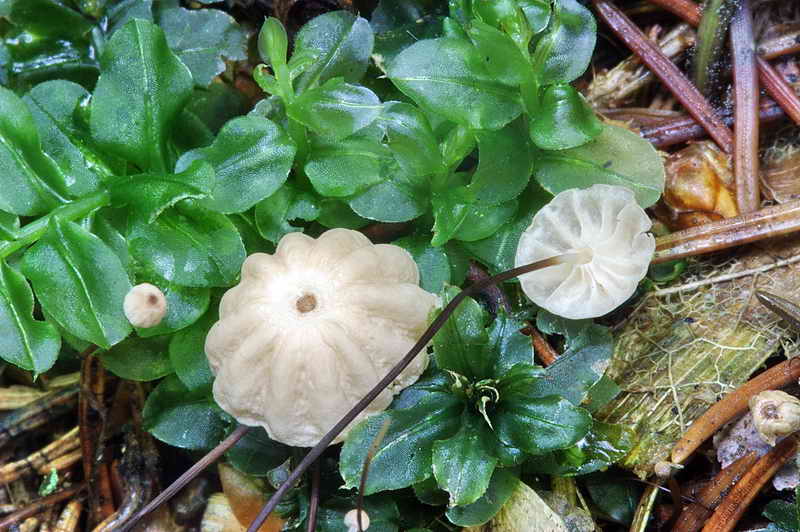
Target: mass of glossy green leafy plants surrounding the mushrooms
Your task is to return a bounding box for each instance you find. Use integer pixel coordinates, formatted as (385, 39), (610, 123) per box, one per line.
(0, 0), (664, 530)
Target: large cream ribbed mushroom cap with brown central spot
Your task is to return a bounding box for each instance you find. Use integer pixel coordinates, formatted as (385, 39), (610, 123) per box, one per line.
(205, 229), (438, 447)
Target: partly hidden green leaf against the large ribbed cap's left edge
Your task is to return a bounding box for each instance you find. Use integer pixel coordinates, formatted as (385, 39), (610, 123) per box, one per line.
(169, 309), (217, 390)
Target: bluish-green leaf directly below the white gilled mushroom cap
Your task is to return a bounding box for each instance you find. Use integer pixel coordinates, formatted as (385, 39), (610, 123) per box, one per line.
(535, 325), (614, 405)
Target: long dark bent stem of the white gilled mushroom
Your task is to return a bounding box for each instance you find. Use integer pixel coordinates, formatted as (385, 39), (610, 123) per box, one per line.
(244, 255), (567, 532)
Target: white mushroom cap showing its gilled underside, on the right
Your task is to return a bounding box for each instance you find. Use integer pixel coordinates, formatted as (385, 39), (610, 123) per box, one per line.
(515, 185), (655, 319)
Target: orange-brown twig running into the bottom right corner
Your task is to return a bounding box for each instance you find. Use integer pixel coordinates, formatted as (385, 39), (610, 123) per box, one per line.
(703, 436), (797, 532)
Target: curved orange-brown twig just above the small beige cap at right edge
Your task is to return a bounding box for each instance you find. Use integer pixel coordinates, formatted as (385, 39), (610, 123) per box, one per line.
(672, 359), (800, 464)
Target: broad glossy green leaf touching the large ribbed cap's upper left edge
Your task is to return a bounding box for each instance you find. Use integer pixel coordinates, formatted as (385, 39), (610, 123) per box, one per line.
(128, 200), (245, 287)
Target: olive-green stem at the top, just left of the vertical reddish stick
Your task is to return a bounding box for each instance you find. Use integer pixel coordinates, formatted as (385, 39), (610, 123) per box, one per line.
(692, 0), (733, 95)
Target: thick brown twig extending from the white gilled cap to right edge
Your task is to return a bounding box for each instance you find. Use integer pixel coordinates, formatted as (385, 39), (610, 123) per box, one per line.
(652, 200), (800, 264)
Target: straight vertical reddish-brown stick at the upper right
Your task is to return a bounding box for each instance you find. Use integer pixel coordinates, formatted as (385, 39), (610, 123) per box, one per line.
(731, 0), (761, 213)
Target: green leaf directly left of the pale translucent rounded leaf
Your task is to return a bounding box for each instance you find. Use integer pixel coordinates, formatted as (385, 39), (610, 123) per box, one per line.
(469, 119), (533, 205)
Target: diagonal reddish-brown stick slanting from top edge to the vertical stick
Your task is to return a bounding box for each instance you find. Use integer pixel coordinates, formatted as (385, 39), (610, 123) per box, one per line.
(594, 0), (733, 153)
